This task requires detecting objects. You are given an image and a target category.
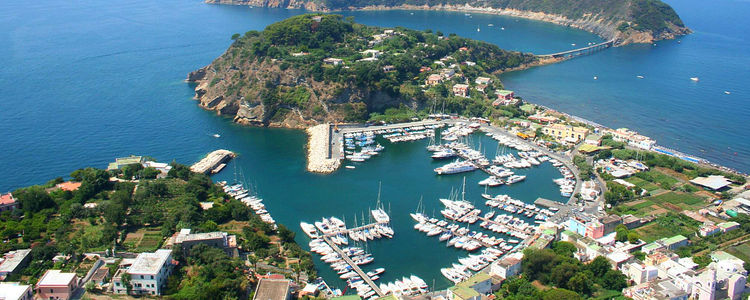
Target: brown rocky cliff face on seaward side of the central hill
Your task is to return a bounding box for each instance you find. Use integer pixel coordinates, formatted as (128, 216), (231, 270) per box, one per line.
(187, 54), (408, 128)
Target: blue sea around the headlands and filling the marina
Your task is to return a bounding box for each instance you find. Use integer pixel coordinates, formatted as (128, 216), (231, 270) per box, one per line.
(0, 0), (750, 288)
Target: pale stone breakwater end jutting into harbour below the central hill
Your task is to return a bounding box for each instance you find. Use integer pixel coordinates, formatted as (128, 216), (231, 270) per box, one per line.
(307, 124), (341, 174)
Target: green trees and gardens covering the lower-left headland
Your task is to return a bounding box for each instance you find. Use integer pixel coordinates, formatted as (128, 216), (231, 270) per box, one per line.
(0, 159), (316, 288)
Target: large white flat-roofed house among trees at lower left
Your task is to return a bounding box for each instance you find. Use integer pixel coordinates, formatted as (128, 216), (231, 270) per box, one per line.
(112, 249), (174, 295)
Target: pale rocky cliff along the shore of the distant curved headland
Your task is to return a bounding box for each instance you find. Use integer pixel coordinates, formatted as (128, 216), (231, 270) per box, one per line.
(205, 0), (691, 45)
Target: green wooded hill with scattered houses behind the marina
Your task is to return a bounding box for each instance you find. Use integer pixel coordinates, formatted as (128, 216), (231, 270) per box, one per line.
(188, 14), (537, 128)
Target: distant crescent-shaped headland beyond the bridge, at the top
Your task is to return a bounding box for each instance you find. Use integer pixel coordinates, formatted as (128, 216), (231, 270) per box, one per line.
(206, 0), (690, 44)
